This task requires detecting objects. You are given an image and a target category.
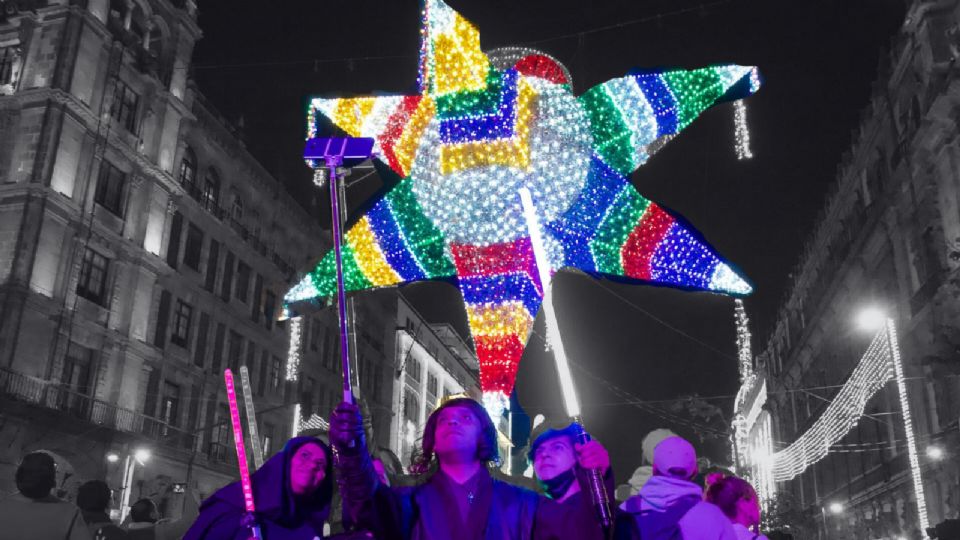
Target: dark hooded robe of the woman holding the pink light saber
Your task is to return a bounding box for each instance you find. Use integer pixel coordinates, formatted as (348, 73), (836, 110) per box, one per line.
(183, 437), (333, 540)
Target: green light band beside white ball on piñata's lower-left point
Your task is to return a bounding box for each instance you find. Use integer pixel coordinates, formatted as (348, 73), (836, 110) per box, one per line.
(386, 177), (456, 278)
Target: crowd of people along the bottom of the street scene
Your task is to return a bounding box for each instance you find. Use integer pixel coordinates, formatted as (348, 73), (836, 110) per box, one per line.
(0, 398), (766, 540)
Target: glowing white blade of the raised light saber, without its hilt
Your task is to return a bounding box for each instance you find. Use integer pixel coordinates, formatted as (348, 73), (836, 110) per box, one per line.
(520, 187), (580, 417)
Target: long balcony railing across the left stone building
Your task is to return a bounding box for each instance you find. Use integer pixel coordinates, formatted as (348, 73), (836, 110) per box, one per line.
(0, 369), (218, 462)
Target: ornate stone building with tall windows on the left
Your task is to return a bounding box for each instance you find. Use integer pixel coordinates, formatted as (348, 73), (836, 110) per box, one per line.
(0, 0), (339, 516)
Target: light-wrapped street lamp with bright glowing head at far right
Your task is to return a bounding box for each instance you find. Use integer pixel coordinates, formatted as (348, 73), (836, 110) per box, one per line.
(857, 306), (930, 531)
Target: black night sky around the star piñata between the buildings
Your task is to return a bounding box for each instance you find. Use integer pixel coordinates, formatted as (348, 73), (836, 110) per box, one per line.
(193, 0), (905, 482)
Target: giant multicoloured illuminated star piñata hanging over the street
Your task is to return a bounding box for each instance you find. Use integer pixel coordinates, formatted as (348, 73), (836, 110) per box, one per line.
(285, 0), (759, 411)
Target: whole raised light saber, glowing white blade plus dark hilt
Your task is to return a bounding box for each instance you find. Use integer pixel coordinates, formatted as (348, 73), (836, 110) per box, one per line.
(519, 187), (613, 530)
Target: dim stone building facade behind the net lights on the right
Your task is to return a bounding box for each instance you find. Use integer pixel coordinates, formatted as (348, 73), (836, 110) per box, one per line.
(757, 0), (960, 538)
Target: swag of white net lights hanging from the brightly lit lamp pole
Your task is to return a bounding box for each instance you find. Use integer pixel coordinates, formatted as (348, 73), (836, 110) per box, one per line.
(772, 312), (929, 530)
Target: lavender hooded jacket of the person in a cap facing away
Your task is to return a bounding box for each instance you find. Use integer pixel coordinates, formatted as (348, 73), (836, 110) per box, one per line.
(617, 476), (737, 540)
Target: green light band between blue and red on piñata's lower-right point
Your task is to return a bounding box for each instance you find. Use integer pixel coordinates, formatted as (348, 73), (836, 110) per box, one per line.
(590, 184), (650, 275)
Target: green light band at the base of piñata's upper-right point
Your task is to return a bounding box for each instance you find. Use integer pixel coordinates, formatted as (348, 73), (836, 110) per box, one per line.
(579, 85), (636, 174)
